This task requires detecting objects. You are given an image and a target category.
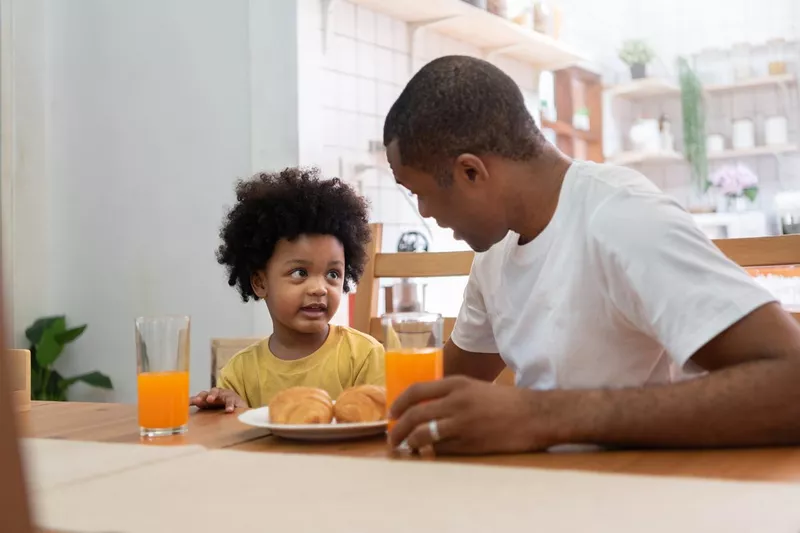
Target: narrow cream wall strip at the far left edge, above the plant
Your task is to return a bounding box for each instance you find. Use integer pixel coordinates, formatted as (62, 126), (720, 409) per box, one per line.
(0, 0), (52, 346)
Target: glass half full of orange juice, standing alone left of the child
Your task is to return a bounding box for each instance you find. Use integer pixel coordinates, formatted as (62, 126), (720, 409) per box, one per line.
(136, 316), (191, 437)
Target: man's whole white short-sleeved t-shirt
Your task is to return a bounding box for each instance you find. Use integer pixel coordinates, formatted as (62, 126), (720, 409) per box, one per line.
(452, 162), (774, 389)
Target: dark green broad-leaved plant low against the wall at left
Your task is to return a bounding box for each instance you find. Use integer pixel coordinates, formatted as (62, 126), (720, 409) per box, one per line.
(25, 316), (113, 401)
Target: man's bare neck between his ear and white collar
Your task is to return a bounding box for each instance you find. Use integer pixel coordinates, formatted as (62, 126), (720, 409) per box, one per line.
(509, 150), (572, 244)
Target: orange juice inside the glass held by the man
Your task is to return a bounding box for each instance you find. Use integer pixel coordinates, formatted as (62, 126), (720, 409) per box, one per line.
(386, 348), (443, 428)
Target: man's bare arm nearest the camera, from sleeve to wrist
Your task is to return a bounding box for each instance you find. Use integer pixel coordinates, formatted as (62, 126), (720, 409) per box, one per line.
(548, 303), (800, 447)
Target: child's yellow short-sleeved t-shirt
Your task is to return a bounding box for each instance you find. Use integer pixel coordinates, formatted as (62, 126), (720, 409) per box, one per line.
(217, 325), (385, 407)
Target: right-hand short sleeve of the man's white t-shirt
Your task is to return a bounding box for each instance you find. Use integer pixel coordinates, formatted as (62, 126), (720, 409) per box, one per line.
(589, 190), (775, 367)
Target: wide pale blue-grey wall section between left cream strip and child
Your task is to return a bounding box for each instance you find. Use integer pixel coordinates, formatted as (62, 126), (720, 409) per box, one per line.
(41, 0), (260, 401)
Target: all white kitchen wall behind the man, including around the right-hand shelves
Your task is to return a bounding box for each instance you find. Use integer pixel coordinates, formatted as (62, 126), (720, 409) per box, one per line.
(322, 0), (800, 315)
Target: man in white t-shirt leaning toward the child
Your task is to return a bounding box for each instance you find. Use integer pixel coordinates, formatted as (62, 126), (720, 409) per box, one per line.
(384, 57), (800, 454)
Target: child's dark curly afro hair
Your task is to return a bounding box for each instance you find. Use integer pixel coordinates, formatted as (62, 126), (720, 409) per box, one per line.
(217, 168), (370, 302)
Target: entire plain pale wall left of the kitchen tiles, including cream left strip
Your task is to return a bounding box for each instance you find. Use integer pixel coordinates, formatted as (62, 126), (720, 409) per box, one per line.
(0, 0), (332, 401)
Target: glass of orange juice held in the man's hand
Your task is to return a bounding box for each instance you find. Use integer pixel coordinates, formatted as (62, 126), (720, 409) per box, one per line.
(381, 313), (444, 428)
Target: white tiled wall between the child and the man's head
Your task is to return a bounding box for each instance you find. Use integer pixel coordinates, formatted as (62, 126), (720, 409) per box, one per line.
(322, 2), (538, 316)
